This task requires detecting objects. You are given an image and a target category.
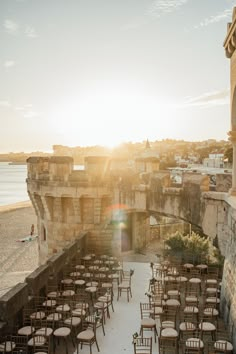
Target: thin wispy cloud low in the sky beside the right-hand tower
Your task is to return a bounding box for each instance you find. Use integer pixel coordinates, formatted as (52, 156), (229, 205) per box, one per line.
(183, 89), (230, 107)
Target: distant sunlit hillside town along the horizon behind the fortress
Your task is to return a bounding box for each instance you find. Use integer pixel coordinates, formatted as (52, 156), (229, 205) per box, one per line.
(0, 139), (233, 170)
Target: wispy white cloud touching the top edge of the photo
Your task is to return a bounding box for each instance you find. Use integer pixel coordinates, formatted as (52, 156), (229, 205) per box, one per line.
(148, 0), (188, 17)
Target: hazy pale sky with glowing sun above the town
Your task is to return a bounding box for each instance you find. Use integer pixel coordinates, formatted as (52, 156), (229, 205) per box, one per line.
(0, 0), (236, 153)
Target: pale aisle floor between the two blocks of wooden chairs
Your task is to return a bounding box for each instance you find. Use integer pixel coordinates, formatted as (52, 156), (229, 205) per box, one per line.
(56, 256), (155, 354)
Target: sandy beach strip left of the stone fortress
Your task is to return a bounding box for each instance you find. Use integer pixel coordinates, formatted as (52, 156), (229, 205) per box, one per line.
(0, 201), (38, 296)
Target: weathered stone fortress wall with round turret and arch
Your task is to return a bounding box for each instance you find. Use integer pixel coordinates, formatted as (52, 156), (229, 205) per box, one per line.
(27, 153), (236, 348)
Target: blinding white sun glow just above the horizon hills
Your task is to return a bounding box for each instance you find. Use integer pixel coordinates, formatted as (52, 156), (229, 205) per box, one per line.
(51, 91), (175, 148)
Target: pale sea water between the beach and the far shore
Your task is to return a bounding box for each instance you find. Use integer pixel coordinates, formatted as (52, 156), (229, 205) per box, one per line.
(0, 162), (29, 206)
